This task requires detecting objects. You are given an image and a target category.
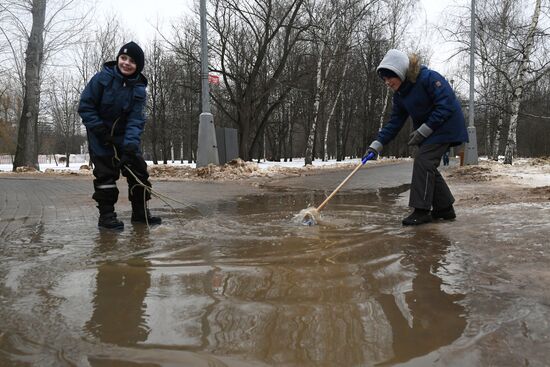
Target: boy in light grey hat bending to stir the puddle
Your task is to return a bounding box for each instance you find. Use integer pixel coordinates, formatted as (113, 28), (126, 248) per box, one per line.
(367, 49), (468, 225)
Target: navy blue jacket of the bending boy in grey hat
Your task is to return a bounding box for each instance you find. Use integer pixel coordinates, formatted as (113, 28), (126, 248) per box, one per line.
(376, 66), (468, 146)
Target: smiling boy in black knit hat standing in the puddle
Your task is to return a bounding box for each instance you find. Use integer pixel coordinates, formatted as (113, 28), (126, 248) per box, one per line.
(78, 42), (161, 229)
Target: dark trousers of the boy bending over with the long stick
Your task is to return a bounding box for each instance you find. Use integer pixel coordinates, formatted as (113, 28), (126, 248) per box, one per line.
(409, 144), (455, 210)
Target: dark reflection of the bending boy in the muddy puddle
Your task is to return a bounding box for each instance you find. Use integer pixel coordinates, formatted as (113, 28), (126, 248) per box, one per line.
(377, 230), (466, 364)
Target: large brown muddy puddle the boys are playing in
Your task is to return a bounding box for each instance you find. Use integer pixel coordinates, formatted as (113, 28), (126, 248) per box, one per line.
(0, 187), (468, 366)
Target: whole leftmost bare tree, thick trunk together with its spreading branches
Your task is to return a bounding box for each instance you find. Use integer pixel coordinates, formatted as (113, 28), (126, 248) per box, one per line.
(0, 0), (90, 170)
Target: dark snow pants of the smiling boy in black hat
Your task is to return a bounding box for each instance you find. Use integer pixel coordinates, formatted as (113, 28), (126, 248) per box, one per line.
(90, 155), (151, 214)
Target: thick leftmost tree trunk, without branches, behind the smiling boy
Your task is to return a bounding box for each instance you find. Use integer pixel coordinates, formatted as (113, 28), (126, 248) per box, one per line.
(13, 0), (46, 171)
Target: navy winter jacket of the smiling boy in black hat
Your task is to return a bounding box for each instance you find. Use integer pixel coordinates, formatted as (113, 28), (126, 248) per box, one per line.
(78, 61), (147, 156)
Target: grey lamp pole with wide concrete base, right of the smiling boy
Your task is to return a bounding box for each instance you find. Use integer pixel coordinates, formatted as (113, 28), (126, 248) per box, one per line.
(197, 0), (220, 167)
